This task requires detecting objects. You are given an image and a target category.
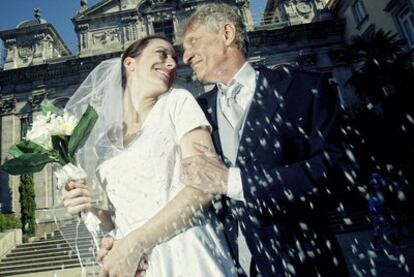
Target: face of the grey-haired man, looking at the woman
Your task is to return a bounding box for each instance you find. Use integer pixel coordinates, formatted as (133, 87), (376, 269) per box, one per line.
(183, 24), (225, 83)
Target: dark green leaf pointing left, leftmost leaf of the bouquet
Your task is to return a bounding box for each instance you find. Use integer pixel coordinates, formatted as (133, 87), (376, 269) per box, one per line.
(0, 153), (56, 175)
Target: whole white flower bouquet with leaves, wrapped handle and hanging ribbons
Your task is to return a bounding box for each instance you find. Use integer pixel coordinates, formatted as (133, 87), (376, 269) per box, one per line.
(0, 100), (100, 270)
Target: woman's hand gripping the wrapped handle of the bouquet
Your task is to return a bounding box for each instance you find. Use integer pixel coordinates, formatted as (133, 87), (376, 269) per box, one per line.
(62, 179), (92, 215)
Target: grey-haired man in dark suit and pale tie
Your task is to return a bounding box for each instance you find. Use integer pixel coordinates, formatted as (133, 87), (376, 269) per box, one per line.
(182, 4), (348, 276)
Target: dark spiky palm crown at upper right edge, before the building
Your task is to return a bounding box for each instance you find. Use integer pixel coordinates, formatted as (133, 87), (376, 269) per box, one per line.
(347, 29), (414, 106)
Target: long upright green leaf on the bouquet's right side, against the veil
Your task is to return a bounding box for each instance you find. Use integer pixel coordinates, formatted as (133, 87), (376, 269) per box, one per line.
(68, 105), (98, 159)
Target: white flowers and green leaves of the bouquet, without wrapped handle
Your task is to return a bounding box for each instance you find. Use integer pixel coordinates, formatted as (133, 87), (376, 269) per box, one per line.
(0, 100), (98, 175)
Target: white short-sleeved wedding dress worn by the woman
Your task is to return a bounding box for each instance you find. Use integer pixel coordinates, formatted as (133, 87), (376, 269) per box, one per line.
(98, 89), (236, 277)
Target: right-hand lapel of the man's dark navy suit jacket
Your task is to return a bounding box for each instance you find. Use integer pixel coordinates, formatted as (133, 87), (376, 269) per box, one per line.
(237, 67), (292, 162)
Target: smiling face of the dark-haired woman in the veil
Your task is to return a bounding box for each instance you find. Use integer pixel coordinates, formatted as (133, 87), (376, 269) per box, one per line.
(124, 38), (177, 95)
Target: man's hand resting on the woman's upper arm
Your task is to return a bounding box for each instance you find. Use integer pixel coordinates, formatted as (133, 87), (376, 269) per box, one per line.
(181, 143), (229, 194)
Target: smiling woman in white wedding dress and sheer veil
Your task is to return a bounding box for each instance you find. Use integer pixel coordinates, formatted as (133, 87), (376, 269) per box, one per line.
(63, 36), (236, 277)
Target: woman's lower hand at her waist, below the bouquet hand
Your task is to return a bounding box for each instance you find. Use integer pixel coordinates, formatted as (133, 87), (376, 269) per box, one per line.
(97, 233), (145, 277)
